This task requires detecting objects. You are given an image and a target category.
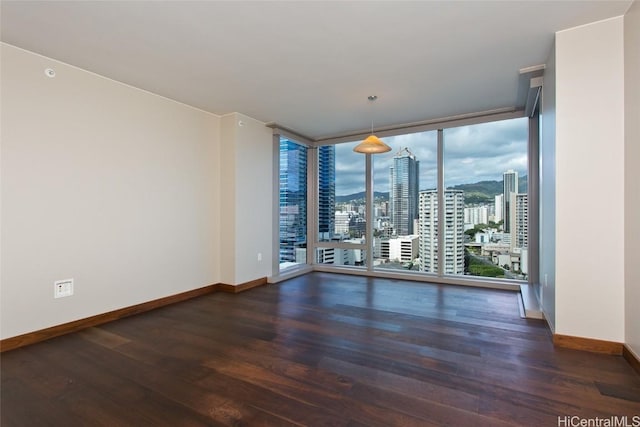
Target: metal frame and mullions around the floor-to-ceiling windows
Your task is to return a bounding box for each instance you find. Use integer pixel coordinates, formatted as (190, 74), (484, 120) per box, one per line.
(270, 108), (540, 290)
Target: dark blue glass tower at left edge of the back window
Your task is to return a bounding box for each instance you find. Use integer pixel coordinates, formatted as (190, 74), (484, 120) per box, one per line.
(318, 145), (336, 241)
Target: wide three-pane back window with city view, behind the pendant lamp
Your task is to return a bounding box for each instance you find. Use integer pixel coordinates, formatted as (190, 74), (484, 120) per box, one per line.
(315, 118), (529, 281)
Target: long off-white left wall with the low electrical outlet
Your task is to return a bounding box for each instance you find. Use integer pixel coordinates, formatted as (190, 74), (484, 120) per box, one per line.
(0, 44), (220, 338)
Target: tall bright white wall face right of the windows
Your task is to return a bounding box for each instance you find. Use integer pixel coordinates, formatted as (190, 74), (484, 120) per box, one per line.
(542, 17), (625, 342)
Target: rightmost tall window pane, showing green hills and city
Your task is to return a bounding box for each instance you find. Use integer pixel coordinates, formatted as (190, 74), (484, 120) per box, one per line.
(444, 118), (528, 279)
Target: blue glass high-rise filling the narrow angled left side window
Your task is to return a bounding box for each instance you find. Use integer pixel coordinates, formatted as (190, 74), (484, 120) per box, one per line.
(279, 138), (307, 263)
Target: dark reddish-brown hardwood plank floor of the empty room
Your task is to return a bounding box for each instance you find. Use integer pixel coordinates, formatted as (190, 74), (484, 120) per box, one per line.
(0, 273), (640, 427)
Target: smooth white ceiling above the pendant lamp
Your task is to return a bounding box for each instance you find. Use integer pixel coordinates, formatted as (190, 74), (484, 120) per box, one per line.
(1, 0), (632, 138)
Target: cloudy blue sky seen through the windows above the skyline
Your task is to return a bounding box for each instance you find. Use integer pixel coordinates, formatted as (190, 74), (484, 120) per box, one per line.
(336, 118), (528, 195)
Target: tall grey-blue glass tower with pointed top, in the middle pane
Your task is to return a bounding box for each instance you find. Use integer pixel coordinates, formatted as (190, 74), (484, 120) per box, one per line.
(389, 148), (420, 236)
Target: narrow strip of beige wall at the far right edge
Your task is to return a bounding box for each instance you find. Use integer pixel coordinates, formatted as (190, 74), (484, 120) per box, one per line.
(624, 1), (640, 358)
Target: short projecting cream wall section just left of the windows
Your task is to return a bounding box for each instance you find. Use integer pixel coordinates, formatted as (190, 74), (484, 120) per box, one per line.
(221, 113), (274, 285)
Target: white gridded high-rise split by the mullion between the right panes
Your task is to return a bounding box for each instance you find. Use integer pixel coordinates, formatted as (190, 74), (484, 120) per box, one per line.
(419, 190), (464, 274)
